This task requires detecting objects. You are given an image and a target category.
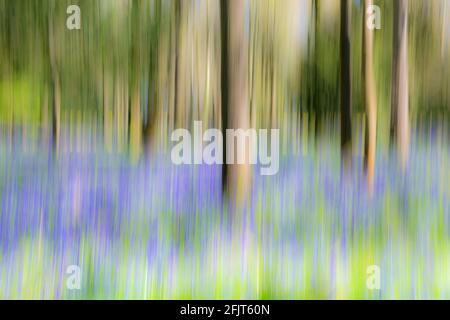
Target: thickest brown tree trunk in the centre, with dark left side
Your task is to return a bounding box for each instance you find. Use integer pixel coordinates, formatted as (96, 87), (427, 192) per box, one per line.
(221, 0), (251, 208)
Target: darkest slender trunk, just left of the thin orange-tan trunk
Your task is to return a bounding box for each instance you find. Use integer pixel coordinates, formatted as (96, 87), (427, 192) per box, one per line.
(340, 0), (352, 171)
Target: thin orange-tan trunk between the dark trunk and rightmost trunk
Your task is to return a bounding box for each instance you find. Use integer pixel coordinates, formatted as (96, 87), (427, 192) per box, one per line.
(363, 0), (377, 194)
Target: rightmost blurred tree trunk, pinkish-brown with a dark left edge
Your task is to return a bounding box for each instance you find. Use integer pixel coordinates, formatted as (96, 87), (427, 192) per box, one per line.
(391, 0), (409, 170)
